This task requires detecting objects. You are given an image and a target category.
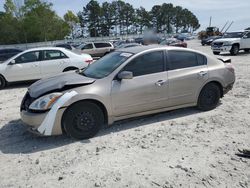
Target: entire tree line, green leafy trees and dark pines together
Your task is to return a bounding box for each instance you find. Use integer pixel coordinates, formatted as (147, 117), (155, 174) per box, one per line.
(0, 0), (200, 44)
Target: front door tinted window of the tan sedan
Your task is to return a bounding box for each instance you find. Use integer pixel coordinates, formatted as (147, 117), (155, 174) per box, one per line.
(123, 51), (164, 77)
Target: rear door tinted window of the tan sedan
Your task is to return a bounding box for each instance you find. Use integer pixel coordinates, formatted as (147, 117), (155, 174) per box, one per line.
(168, 50), (206, 70)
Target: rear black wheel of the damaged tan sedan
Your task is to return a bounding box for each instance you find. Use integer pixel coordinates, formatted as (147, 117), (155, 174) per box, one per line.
(198, 83), (221, 111)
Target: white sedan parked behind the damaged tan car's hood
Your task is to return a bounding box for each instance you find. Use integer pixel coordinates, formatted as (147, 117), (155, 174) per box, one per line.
(0, 47), (93, 89)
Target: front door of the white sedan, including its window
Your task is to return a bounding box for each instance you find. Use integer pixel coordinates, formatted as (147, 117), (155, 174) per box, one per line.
(5, 51), (41, 82)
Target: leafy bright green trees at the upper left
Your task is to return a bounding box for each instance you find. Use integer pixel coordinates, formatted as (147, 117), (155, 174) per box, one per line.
(0, 0), (70, 44)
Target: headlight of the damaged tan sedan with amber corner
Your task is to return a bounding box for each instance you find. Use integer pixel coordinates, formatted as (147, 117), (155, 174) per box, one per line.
(29, 93), (63, 110)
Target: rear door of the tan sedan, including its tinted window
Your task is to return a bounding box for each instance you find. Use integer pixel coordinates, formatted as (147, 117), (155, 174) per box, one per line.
(168, 50), (208, 106)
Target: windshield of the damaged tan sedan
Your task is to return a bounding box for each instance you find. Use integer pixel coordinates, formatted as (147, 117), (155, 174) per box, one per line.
(82, 52), (133, 79)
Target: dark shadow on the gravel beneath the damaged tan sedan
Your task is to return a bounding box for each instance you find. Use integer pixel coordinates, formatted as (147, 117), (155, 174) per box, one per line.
(0, 108), (201, 154)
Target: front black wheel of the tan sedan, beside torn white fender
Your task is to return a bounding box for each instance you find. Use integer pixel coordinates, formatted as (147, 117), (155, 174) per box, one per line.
(62, 102), (104, 139)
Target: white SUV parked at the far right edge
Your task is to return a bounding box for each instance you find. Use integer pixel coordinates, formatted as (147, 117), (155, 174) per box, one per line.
(211, 30), (250, 55)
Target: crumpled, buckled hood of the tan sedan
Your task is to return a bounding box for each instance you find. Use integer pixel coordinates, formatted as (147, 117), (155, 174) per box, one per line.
(28, 72), (95, 98)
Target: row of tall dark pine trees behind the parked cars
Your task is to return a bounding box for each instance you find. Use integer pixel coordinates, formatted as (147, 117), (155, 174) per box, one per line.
(78, 0), (200, 37)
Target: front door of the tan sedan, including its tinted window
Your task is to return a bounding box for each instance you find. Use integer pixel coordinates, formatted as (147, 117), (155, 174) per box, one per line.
(111, 51), (168, 117)
